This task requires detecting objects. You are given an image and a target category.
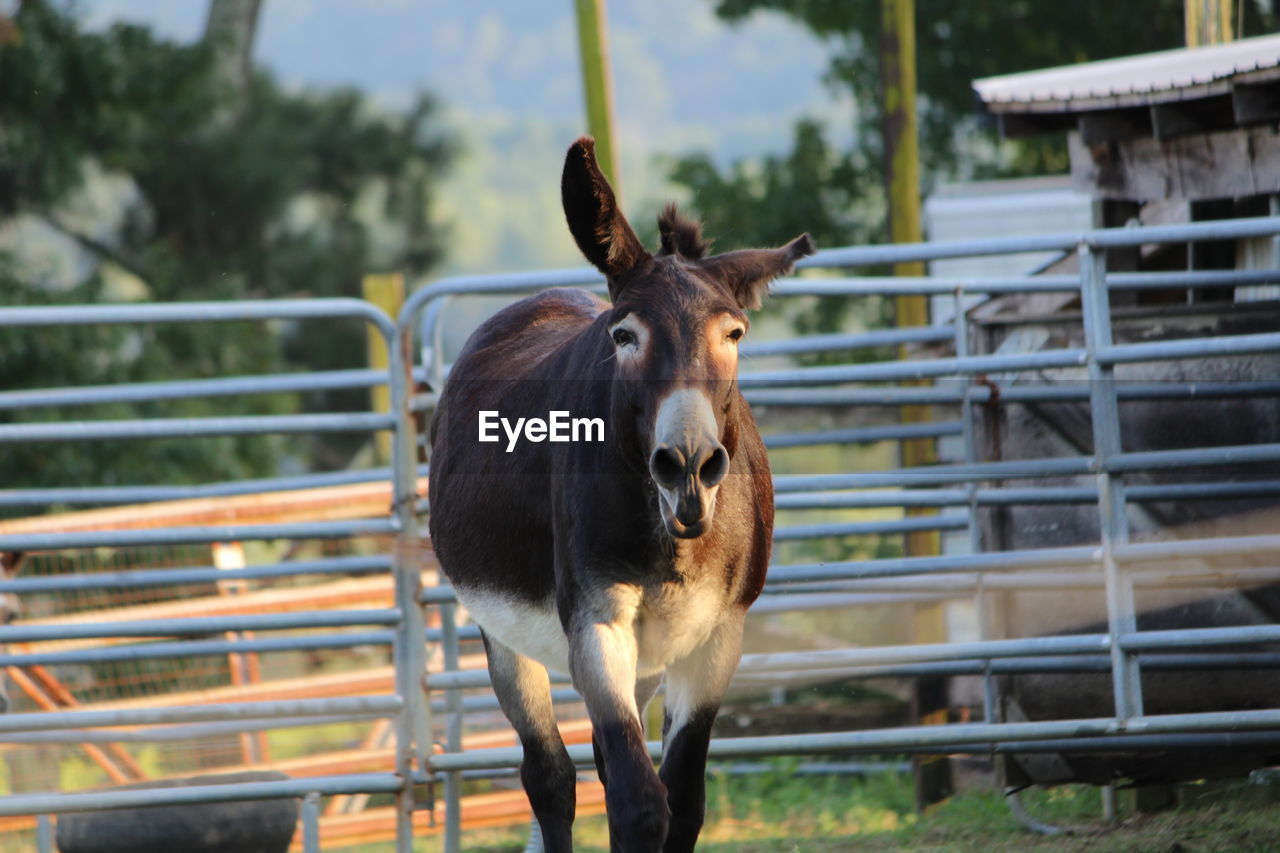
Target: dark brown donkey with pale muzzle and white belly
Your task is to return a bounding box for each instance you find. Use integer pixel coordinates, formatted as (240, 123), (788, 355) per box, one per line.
(430, 137), (814, 853)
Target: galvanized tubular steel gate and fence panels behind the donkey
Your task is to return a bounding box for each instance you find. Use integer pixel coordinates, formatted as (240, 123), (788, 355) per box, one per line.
(0, 218), (1280, 852)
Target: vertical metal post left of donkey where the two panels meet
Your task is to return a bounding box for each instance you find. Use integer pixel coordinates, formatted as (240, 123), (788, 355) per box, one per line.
(387, 317), (431, 853)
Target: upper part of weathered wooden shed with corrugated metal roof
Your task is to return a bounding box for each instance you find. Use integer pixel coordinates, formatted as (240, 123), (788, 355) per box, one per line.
(974, 35), (1280, 202)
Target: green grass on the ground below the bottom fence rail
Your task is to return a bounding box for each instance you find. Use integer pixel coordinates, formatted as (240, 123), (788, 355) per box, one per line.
(404, 761), (1280, 853)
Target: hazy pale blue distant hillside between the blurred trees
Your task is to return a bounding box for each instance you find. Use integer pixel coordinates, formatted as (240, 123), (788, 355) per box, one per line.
(78, 0), (852, 272)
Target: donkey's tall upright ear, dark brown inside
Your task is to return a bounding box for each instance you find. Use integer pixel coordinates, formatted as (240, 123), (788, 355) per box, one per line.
(561, 136), (650, 290)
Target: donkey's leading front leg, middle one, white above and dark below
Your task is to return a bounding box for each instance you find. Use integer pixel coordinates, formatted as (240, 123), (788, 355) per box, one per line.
(568, 588), (669, 853)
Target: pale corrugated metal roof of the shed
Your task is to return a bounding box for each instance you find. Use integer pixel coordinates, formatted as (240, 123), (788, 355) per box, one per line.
(973, 35), (1280, 113)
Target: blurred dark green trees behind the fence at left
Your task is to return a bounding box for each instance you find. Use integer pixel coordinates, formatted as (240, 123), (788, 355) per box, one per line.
(0, 0), (452, 487)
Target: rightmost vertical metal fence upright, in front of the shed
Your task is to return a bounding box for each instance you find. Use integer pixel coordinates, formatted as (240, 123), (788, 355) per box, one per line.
(1079, 243), (1143, 725)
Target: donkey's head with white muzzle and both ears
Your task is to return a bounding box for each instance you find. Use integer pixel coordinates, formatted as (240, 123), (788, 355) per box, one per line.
(561, 137), (814, 539)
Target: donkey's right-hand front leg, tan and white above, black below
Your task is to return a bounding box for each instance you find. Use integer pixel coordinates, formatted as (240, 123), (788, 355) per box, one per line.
(659, 611), (744, 853)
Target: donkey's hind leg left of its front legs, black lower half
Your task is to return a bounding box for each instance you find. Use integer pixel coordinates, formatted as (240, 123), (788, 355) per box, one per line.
(484, 634), (577, 853)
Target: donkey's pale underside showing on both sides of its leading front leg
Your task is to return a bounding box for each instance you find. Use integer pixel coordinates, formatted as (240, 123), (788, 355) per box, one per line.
(457, 578), (723, 678)
